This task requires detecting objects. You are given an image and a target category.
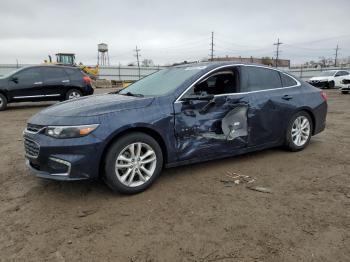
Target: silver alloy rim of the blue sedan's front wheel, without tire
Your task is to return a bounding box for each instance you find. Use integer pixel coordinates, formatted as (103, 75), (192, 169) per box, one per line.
(115, 142), (157, 187)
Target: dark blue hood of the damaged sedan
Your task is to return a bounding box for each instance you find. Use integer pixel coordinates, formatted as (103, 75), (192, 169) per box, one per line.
(36, 94), (154, 117)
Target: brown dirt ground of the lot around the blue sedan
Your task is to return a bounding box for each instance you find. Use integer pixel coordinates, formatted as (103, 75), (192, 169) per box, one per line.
(0, 90), (350, 262)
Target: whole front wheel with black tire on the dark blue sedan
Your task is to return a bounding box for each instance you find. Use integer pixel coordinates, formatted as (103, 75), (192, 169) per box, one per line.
(104, 132), (163, 194)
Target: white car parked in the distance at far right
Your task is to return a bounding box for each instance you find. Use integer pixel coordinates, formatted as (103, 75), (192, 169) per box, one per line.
(307, 70), (349, 88)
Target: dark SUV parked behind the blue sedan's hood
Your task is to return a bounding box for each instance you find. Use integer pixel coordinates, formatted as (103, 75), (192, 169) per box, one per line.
(0, 65), (94, 111)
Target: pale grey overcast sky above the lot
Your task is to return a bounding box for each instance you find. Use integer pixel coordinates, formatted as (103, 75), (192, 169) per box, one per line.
(0, 0), (350, 64)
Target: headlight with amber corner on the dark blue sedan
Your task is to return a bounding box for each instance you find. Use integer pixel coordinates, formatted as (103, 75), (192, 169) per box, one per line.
(45, 124), (99, 138)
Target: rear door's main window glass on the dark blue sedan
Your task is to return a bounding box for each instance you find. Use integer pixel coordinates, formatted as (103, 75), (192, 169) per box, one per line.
(245, 66), (282, 91)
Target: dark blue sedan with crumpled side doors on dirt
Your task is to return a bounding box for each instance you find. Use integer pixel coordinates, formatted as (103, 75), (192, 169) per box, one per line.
(24, 63), (327, 194)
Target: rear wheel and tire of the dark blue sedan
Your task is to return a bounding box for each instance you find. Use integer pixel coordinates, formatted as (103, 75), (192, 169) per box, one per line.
(286, 111), (313, 151)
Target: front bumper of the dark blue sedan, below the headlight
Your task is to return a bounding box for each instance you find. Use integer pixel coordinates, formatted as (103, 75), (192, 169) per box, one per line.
(23, 131), (103, 181)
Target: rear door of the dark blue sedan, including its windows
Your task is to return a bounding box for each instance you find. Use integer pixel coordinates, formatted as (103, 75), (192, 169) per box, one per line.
(240, 65), (300, 147)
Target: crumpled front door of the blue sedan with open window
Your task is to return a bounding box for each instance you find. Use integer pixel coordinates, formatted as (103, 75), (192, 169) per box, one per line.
(174, 66), (248, 160)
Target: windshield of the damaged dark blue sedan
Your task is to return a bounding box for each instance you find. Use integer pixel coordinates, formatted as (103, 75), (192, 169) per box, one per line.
(119, 66), (205, 96)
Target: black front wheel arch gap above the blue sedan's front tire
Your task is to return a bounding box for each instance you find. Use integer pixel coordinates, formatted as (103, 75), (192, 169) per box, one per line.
(99, 125), (168, 178)
